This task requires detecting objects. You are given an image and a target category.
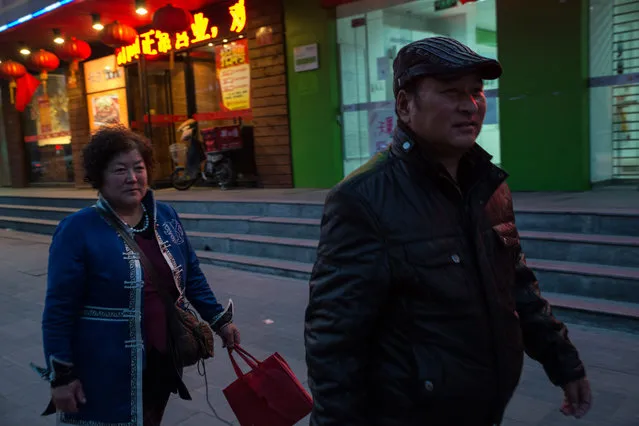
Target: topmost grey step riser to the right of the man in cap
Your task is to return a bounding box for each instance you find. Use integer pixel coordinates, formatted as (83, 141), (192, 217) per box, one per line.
(515, 207), (639, 237)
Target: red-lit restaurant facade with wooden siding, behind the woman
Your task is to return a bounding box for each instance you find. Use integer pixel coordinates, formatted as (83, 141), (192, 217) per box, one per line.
(0, 0), (293, 187)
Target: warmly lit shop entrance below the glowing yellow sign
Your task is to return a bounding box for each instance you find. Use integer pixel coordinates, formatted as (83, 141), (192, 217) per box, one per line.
(126, 37), (256, 187)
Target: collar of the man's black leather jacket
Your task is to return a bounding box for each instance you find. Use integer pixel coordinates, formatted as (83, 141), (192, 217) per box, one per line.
(391, 122), (508, 189)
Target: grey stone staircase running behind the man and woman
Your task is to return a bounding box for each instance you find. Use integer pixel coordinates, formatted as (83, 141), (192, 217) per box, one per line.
(0, 196), (639, 333)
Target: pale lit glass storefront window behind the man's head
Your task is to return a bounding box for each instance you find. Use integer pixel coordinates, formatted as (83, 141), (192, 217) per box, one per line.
(337, 0), (500, 175)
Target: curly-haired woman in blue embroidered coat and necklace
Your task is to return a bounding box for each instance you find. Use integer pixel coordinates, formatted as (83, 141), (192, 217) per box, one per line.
(42, 127), (239, 426)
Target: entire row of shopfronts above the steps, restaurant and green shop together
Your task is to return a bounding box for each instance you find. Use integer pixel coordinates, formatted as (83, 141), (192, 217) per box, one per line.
(0, 0), (639, 191)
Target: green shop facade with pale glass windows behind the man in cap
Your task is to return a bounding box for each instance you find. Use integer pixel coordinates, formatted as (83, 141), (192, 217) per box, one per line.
(289, 0), (639, 191)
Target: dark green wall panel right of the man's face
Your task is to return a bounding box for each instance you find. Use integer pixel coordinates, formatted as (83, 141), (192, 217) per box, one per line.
(497, 0), (590, 191)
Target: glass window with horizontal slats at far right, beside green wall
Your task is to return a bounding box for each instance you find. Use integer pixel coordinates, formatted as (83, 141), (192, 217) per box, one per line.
(589, 0), (639, 182)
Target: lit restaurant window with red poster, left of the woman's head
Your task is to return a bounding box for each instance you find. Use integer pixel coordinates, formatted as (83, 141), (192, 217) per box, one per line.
(22, 74), (74, 183)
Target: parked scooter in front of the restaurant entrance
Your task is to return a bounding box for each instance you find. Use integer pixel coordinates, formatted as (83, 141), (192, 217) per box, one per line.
(171, 119), (234, 191)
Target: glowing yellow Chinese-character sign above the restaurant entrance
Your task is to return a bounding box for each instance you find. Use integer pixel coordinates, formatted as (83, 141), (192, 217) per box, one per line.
(116, 0), (246, 65)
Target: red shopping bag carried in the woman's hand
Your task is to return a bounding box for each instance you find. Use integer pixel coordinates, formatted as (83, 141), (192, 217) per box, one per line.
(223, 346), (313, 426)
